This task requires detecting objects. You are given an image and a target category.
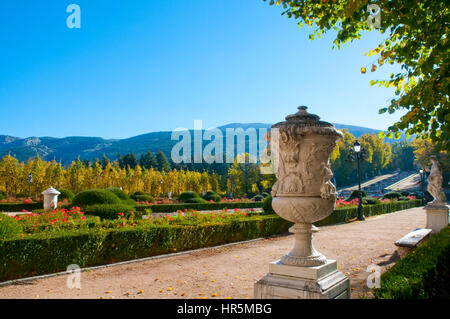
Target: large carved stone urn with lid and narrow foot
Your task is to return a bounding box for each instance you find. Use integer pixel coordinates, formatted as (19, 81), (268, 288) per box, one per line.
(267, 106), (343, 267)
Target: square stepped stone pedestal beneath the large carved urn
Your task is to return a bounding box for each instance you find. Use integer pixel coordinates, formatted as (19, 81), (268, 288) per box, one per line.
(254, 260), (350, 299)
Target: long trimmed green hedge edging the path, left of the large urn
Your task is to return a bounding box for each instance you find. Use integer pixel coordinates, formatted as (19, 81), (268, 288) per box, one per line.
(0, 215), (292, 281)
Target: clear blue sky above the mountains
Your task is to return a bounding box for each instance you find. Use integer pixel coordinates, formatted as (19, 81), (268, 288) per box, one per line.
(0, 0), (400, 138)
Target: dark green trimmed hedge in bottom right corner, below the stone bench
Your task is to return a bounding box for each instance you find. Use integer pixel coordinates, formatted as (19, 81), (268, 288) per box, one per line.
(374, 226), (450, 299)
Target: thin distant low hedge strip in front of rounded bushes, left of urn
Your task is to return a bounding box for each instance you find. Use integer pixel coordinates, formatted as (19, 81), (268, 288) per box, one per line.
(136, 202), (262, 213)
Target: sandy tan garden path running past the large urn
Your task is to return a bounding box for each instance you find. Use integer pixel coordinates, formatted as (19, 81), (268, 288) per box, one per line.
(0, 208), (426, 299)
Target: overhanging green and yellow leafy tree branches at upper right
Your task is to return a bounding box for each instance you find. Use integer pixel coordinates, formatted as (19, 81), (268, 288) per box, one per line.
(264, 0), (450, 150)
